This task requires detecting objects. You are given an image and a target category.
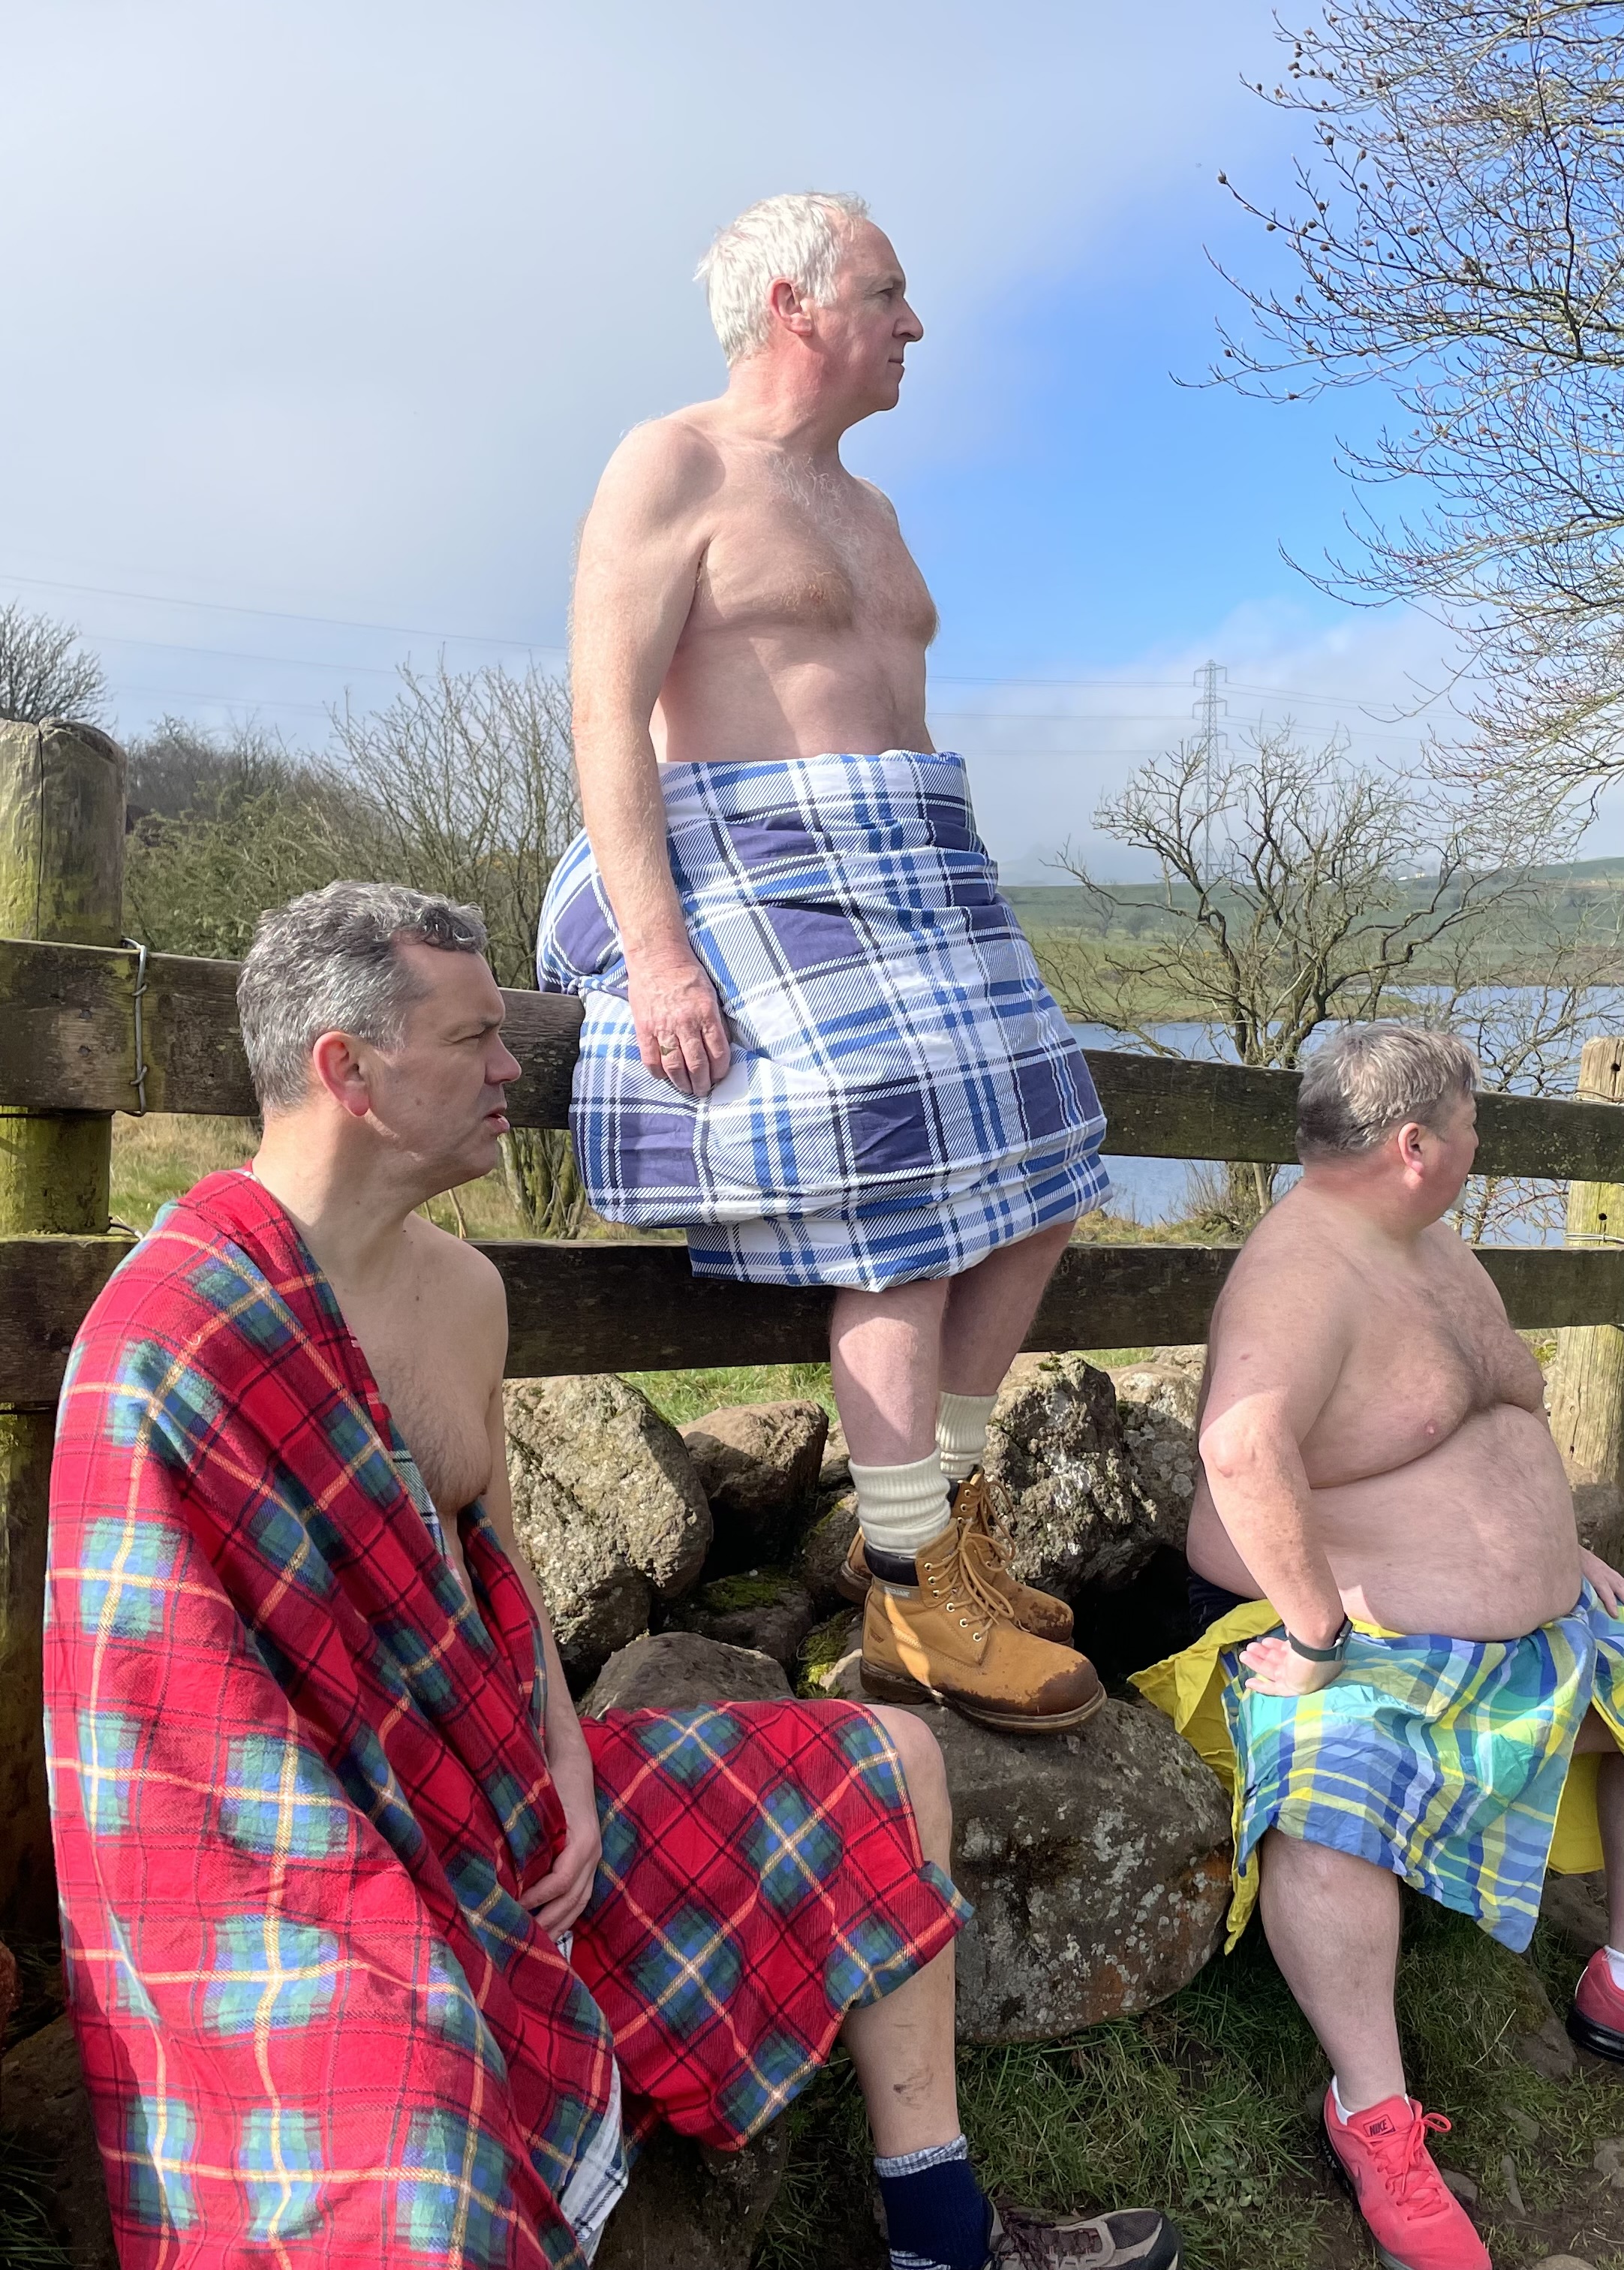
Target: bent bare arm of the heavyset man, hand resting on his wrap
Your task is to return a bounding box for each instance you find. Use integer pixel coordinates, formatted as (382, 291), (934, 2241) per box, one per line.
(1200, 1255), (1349, 1684)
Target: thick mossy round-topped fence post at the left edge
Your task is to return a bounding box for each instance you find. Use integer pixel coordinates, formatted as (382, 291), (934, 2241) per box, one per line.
(0, 720), (125, 1941)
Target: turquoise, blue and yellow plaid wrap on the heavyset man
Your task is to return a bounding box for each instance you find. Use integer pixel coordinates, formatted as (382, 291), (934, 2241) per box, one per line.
(1134, 1585), (1624, 1950)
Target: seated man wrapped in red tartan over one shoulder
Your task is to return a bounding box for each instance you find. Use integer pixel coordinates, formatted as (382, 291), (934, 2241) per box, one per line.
(45, 883), (1180, 2270)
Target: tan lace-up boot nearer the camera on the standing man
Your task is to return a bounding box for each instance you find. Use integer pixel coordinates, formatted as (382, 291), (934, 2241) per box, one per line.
(859, 1521), (1105, 1734)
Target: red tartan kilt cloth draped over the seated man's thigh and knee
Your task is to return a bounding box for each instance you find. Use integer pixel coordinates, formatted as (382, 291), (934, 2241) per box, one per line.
(574, 1702), (971, 2139)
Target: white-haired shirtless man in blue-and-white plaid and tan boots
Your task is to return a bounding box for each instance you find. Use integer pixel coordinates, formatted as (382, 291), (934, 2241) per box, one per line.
(540, 195), (1107, 1732)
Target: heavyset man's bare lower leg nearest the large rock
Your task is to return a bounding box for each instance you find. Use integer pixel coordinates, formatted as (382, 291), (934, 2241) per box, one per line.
(1261, 1829), (1406, 2113)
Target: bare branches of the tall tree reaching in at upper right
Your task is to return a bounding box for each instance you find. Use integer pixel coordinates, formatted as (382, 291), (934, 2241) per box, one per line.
(1216, 0), (1624, 808)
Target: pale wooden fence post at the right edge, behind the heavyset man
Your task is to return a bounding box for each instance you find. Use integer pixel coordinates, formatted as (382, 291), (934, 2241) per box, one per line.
(1551, 1040), (1624, 1557)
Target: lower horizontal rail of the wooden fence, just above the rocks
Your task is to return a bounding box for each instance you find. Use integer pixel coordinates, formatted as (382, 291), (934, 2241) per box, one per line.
(0, 1237), (1624, 1407)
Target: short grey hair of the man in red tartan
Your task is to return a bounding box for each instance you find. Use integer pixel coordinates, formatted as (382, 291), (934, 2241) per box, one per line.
(236, 883), (486, 1110)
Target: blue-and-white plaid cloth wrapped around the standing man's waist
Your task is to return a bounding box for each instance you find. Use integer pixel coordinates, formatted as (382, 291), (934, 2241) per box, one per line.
(537, 749), (1109, 1290)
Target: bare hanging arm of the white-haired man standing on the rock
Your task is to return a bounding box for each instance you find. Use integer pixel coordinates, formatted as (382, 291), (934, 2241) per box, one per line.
(572, 420), (730, 1097)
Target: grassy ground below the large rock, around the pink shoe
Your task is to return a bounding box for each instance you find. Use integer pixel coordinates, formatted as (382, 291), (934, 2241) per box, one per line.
(755, 1898), (1624, 2270)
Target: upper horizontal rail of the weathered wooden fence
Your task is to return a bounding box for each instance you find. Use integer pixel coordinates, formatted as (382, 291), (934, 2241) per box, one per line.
(0, 938), (1624, 1171)
